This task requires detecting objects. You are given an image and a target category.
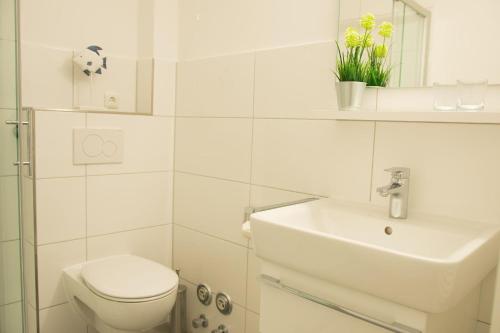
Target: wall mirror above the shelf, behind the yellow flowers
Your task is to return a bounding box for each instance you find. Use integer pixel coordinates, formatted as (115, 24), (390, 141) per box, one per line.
(339, 0), (500, 87)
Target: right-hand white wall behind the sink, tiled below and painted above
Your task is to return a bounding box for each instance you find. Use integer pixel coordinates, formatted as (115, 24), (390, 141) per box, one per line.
(174, 0), (500, 333)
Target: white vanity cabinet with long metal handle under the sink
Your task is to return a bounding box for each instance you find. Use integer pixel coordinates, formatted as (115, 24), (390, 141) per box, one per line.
(260, 262), (480, 333)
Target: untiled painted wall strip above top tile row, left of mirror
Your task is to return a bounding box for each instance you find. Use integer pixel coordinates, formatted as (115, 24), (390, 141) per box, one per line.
(179, 0), (338, 60)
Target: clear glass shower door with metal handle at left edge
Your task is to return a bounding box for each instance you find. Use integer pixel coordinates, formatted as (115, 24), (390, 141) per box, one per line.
(0, 0), (24, 333)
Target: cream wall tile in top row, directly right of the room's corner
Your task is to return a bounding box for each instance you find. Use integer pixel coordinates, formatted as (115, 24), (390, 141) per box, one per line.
(176, 53), (255, 117)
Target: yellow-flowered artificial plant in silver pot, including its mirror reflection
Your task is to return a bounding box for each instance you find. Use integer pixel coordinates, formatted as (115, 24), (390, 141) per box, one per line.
(335, 13), (392, 111)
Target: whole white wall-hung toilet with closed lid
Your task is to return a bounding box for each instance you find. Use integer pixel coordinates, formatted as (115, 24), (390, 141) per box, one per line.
(63, 255), (179, 333)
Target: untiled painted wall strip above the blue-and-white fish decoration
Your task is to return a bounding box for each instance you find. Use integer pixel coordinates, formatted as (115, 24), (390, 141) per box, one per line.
(20, 0), (138, 56)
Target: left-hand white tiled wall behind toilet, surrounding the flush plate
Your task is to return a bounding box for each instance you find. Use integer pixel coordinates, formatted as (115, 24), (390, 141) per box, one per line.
(21, 0), (177, 333)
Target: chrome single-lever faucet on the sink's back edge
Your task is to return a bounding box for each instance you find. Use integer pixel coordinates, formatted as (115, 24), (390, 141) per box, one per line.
(377, 167), (410, 219)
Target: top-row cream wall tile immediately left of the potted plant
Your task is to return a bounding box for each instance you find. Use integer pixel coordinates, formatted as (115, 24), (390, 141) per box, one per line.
(255, 42), (337, 118)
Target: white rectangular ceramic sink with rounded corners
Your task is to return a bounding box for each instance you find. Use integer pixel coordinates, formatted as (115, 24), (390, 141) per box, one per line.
(251, 199), (500, 313)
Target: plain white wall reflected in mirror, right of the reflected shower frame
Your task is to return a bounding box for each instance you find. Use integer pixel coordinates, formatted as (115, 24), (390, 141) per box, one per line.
(428, 0), (500, 84)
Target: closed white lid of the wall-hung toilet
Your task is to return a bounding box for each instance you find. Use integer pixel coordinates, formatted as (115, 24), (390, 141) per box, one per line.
(81, 255), (179, 299)
